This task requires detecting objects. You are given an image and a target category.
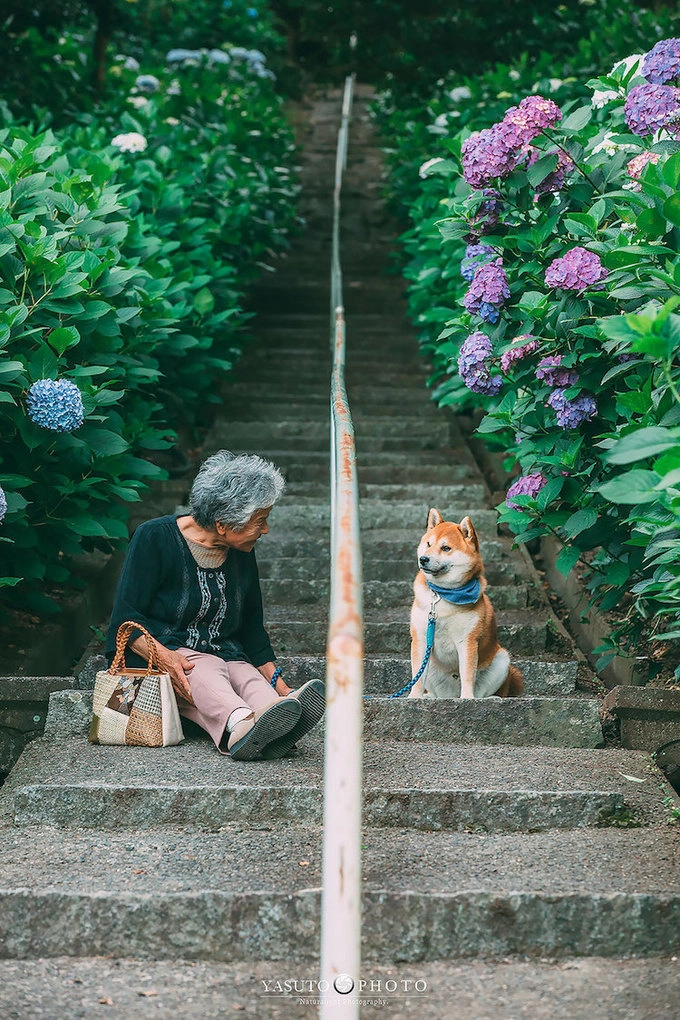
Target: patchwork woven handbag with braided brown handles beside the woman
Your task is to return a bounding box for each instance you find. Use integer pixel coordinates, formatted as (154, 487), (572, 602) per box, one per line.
(89, 620), (185, 748)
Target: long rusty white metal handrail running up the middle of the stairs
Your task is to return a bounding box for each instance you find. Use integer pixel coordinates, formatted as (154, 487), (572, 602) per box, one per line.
(319, 75), (364, 1020)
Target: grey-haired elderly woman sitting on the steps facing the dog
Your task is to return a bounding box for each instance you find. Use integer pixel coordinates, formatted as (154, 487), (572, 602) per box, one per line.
(106, 450), (324, 761)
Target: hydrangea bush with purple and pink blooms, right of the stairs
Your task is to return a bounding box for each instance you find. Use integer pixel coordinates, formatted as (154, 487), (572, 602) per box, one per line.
(381, 29), (680, 654)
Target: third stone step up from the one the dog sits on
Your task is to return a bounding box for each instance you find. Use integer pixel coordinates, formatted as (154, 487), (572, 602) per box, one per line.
(261, 578), (527, 613)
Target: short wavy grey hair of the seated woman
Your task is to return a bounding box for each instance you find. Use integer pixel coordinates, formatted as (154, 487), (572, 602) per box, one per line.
(189, 450), (285, 531)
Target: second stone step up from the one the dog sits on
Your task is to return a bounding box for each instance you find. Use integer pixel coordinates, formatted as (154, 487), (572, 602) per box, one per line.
(265, 606), (547, 657)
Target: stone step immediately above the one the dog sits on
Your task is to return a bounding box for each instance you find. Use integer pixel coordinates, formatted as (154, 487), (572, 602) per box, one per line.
(277, 655), (578, 698)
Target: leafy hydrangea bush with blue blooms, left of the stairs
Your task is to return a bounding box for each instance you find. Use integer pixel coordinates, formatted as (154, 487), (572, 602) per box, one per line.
(0, 27), (297, 609)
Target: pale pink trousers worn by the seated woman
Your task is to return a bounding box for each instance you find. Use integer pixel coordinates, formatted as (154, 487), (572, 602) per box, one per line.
(177, 648), (278, 750)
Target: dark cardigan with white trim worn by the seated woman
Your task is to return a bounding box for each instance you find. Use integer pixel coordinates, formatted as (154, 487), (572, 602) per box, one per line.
(106, 514), (274, 666)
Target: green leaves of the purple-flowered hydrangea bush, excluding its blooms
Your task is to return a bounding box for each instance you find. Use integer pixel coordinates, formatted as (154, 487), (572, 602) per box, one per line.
(379, 21), (680, 654)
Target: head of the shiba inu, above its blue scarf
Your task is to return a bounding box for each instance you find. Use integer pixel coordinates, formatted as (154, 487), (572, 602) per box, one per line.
(418, 509), (482, 588)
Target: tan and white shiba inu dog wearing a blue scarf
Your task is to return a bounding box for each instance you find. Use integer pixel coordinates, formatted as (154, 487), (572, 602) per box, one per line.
(409, 509), (524, 698)
